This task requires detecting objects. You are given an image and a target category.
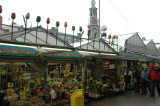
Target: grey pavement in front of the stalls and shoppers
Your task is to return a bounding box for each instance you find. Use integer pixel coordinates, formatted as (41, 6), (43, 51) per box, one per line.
(85, 92), (160, 106)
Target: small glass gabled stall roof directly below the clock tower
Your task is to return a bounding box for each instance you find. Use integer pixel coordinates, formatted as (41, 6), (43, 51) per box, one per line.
(71, 38), (118, 55)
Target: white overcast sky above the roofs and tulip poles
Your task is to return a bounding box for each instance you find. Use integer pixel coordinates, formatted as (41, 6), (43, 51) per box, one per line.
(0, 0), (160, 42)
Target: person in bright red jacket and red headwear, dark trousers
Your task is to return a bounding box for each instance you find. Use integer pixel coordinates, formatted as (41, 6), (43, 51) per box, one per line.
(148, 64), (156, 97)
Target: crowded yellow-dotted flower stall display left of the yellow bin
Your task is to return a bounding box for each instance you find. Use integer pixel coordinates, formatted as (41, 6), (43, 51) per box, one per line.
(0, 63), (84, 106)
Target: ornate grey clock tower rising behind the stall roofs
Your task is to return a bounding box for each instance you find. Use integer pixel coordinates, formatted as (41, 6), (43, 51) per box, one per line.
(88, 0), (100, 38)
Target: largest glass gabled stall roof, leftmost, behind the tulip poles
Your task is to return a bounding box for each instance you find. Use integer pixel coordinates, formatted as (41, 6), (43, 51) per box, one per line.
(0, 25), (74, 53)
